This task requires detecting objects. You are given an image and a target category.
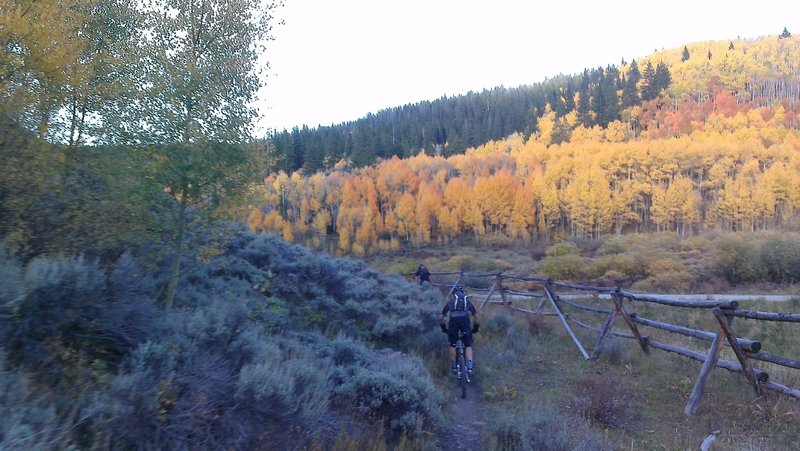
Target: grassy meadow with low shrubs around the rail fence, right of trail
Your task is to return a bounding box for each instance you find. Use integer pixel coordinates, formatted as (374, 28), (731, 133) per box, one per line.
(370, 234), (800, 450)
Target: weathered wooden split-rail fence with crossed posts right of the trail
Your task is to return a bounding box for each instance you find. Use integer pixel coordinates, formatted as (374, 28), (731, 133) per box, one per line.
(404, 272), (800, 415)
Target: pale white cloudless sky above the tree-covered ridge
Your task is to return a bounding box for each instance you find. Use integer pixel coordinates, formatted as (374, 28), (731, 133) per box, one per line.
(256, 0), (800, 136)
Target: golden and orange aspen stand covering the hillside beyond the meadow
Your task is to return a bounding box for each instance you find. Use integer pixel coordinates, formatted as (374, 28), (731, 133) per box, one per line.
(253, 37), (800, 255)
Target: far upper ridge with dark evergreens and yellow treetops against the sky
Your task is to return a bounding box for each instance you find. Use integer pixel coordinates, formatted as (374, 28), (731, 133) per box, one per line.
(269, 33), (800, 174)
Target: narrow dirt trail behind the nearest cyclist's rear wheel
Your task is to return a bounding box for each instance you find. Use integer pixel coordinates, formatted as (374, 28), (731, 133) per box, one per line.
(442, 381), (484, 451)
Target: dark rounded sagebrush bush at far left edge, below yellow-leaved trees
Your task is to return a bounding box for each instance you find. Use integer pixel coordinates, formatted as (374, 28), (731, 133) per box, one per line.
(0, 256), (157, 383)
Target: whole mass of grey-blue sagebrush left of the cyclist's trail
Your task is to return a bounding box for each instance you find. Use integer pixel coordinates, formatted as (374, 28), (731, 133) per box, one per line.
(0, 230), (443, 449)
